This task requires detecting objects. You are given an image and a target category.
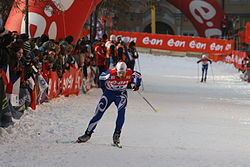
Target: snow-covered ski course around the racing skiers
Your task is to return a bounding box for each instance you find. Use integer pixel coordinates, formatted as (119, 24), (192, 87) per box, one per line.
(0, 54), (250, 167)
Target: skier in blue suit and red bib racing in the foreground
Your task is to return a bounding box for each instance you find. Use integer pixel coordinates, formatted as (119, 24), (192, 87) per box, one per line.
(77, 61), (141, 145)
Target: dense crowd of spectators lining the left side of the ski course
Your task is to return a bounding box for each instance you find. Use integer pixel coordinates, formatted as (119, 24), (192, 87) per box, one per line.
(0, 29), (138, 127)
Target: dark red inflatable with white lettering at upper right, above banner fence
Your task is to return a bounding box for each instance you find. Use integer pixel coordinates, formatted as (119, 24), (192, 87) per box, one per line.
(168, 0), (224, 38)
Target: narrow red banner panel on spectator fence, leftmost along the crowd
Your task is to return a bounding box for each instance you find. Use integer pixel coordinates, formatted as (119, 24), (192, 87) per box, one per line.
(48, 72), (60, 99)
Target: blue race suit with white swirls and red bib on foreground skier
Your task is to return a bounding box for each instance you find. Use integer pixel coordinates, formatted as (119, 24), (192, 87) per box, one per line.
(86, 68), (141, 134)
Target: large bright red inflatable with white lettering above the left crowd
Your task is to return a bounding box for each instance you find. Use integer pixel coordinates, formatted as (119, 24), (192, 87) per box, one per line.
(5, 0), (101, 41)
